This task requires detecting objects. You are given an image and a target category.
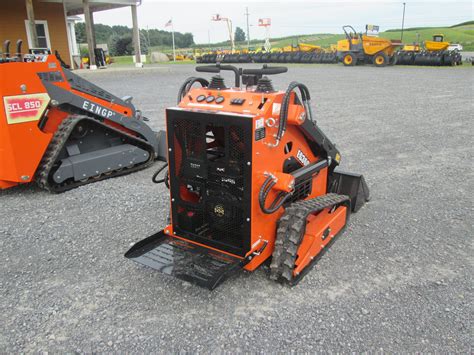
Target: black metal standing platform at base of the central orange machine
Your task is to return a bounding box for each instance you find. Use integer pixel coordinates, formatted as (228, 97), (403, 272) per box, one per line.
(125, 231), (242, 290)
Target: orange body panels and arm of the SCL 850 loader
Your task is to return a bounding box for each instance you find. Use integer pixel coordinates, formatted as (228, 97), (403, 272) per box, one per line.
(0, 55), (139, 189)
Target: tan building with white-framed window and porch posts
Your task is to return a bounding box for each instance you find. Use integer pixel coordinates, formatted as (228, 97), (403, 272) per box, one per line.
(0, 0), (141, 69)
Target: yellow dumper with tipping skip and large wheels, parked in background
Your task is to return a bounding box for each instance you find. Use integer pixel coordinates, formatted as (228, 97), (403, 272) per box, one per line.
(337, 25), (402, 67)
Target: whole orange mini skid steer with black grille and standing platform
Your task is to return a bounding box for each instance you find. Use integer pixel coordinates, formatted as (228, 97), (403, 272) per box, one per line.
(125, 64), (369, 289)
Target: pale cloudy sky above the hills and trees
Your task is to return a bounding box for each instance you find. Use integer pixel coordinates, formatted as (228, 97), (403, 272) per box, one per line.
(94, 0), (474, 43)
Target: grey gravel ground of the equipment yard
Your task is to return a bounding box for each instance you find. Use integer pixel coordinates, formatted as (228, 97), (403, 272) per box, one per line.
(0, 65), (474, 353)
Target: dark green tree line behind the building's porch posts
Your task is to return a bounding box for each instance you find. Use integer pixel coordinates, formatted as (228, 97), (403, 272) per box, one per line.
(75, 22), (194, 56)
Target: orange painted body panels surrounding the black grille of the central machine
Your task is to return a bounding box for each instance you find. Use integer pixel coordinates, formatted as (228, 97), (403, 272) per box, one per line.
(165, 88), (340, 271)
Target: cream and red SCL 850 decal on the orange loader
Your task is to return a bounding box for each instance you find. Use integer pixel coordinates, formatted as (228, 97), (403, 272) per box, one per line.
(3, 93), (50, 124)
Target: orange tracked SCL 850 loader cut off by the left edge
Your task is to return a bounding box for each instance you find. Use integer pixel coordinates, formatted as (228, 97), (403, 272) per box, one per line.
(0, 40), (159, 192)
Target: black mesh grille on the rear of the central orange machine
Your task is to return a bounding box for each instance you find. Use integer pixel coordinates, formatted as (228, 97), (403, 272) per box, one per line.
(171, 114), (249, 253)
